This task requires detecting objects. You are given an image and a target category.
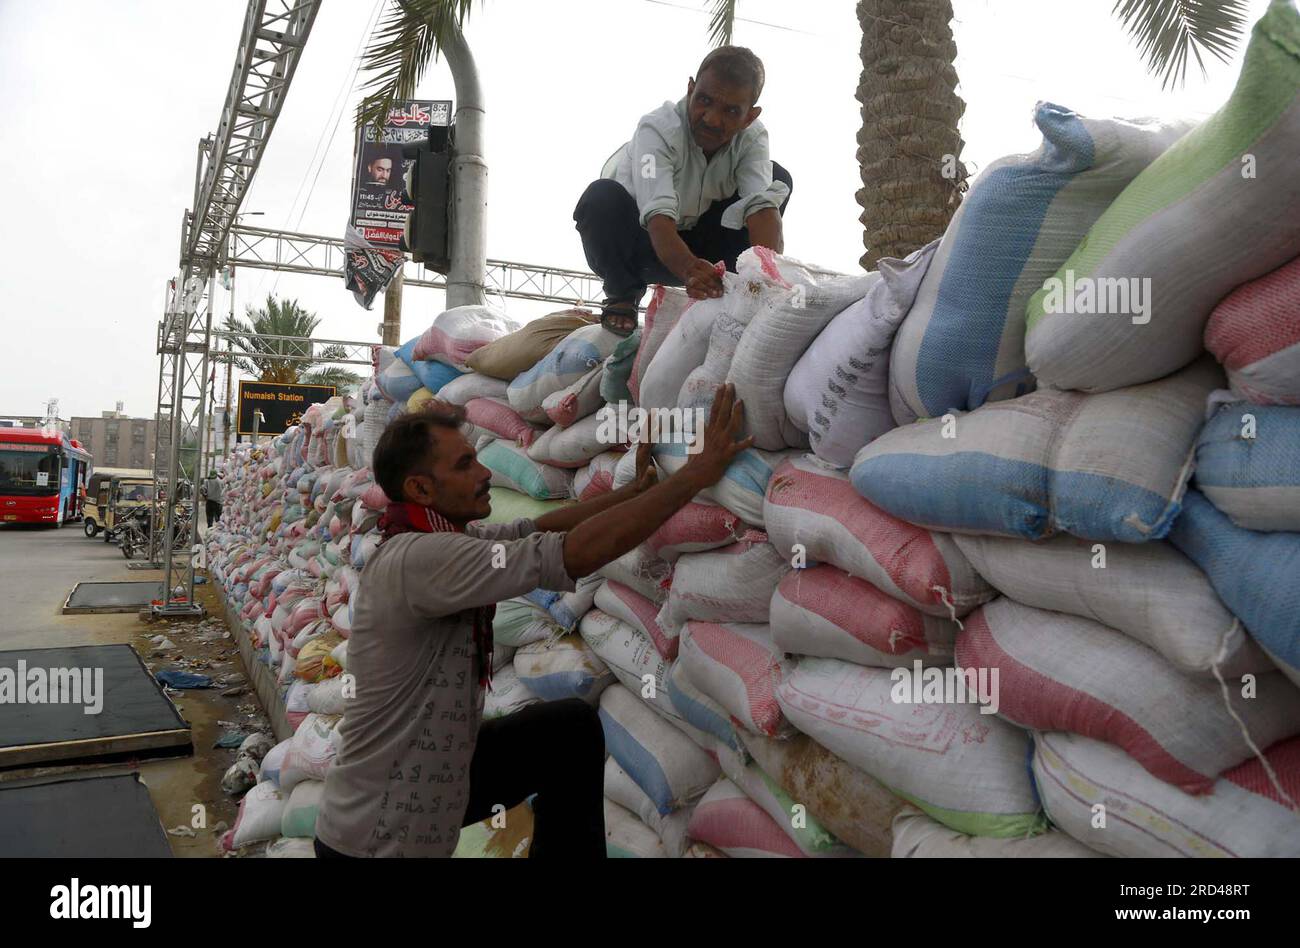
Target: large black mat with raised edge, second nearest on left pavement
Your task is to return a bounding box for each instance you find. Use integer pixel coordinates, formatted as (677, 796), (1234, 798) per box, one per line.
(0, 645), (190, 767)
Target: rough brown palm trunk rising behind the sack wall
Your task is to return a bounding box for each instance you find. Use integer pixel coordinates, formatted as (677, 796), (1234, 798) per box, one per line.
(857, 0), (966, 269)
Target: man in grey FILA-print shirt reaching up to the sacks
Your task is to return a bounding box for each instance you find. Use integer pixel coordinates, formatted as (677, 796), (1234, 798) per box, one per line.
(316, 385), (751, 858)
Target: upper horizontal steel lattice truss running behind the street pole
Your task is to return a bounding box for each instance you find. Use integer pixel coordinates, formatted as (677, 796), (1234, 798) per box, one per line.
(228, 224), (603, 304)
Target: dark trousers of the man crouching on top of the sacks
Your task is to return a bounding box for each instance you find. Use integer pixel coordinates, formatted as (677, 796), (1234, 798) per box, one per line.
(573, 161), (794, 299)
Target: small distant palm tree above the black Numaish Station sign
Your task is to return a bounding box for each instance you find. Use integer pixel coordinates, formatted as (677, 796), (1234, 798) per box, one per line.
(221, 294), (361, 393)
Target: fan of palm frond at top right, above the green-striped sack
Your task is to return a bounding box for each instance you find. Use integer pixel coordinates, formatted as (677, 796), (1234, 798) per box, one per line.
(1112, 0), (1248, 88)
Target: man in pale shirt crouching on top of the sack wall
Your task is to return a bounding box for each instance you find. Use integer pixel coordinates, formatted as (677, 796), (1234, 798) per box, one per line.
(573, 46), (793, 336)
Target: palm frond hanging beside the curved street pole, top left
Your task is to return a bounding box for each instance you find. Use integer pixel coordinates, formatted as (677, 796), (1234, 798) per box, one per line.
(356, 0), (475, 126)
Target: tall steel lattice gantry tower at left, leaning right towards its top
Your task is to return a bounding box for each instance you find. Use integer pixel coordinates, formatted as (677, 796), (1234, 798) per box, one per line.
(150, 0), (320, 616)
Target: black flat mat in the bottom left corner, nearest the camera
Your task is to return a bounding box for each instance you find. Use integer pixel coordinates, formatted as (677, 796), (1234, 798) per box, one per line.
(0, 774), (172, 858)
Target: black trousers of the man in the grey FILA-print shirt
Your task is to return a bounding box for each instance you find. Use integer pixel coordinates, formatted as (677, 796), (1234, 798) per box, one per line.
(316, 698), (605, 860)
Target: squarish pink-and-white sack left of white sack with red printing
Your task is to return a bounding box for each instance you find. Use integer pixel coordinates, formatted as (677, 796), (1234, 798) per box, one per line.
(677, 622), (790, 737)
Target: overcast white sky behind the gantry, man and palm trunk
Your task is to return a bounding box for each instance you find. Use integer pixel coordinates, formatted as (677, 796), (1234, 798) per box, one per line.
(0, 0), (1268, 417)
